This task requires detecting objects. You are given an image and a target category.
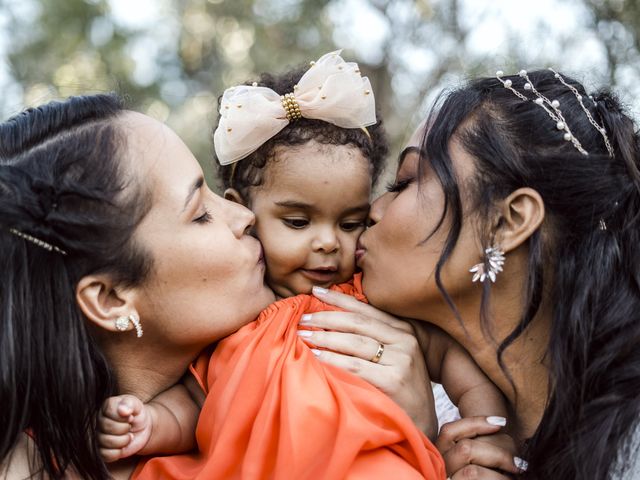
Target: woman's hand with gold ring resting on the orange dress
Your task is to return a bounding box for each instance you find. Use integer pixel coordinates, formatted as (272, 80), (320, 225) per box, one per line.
(299, 288), (438, 439)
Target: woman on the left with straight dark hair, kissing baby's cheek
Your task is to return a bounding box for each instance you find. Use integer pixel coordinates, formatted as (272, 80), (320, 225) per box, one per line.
(0, 95), (274, 479)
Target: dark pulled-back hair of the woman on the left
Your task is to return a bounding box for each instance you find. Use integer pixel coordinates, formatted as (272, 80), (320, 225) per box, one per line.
(0, 95), (151, 479)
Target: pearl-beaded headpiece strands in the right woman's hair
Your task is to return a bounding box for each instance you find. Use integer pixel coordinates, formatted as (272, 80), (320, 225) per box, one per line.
(496, 68), (614, 157)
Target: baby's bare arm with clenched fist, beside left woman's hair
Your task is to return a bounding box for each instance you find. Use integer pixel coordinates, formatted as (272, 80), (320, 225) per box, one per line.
(98, 375), (200, 462)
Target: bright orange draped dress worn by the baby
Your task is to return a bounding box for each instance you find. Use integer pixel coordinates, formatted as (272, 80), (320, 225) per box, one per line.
(133, 276), (446, 480)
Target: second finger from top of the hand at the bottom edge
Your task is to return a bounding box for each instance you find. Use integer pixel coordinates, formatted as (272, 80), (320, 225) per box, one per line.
(442, 438), (520, 478)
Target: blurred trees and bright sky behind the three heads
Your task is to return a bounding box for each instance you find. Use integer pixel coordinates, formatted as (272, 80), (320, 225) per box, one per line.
(0, 0), (640, 184)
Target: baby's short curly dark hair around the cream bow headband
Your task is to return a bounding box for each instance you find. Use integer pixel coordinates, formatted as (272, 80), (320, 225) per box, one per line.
(214, 64), (389, 199)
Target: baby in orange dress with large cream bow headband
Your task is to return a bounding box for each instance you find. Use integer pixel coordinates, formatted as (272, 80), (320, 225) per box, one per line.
(100, 52), (506, 478)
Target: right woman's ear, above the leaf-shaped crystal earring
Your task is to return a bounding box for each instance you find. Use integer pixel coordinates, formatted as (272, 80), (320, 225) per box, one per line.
(497, 188), (545, 253)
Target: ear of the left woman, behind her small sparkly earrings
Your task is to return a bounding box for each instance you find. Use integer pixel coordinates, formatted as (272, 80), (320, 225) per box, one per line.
(76, 274), (138, 332)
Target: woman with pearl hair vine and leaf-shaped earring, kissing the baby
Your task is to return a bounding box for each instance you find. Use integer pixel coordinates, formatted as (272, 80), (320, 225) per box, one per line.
(298, 70), (640, 479)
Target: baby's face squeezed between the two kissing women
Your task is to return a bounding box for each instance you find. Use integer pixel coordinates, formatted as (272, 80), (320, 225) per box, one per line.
(250, 141), (371, 297)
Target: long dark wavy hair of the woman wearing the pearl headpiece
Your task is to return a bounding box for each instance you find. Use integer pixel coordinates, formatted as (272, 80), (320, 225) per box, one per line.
(420, 70), (640, 480)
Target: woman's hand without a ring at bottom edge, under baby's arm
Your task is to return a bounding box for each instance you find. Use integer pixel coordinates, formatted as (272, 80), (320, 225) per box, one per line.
(436, 417), (527, 480)
